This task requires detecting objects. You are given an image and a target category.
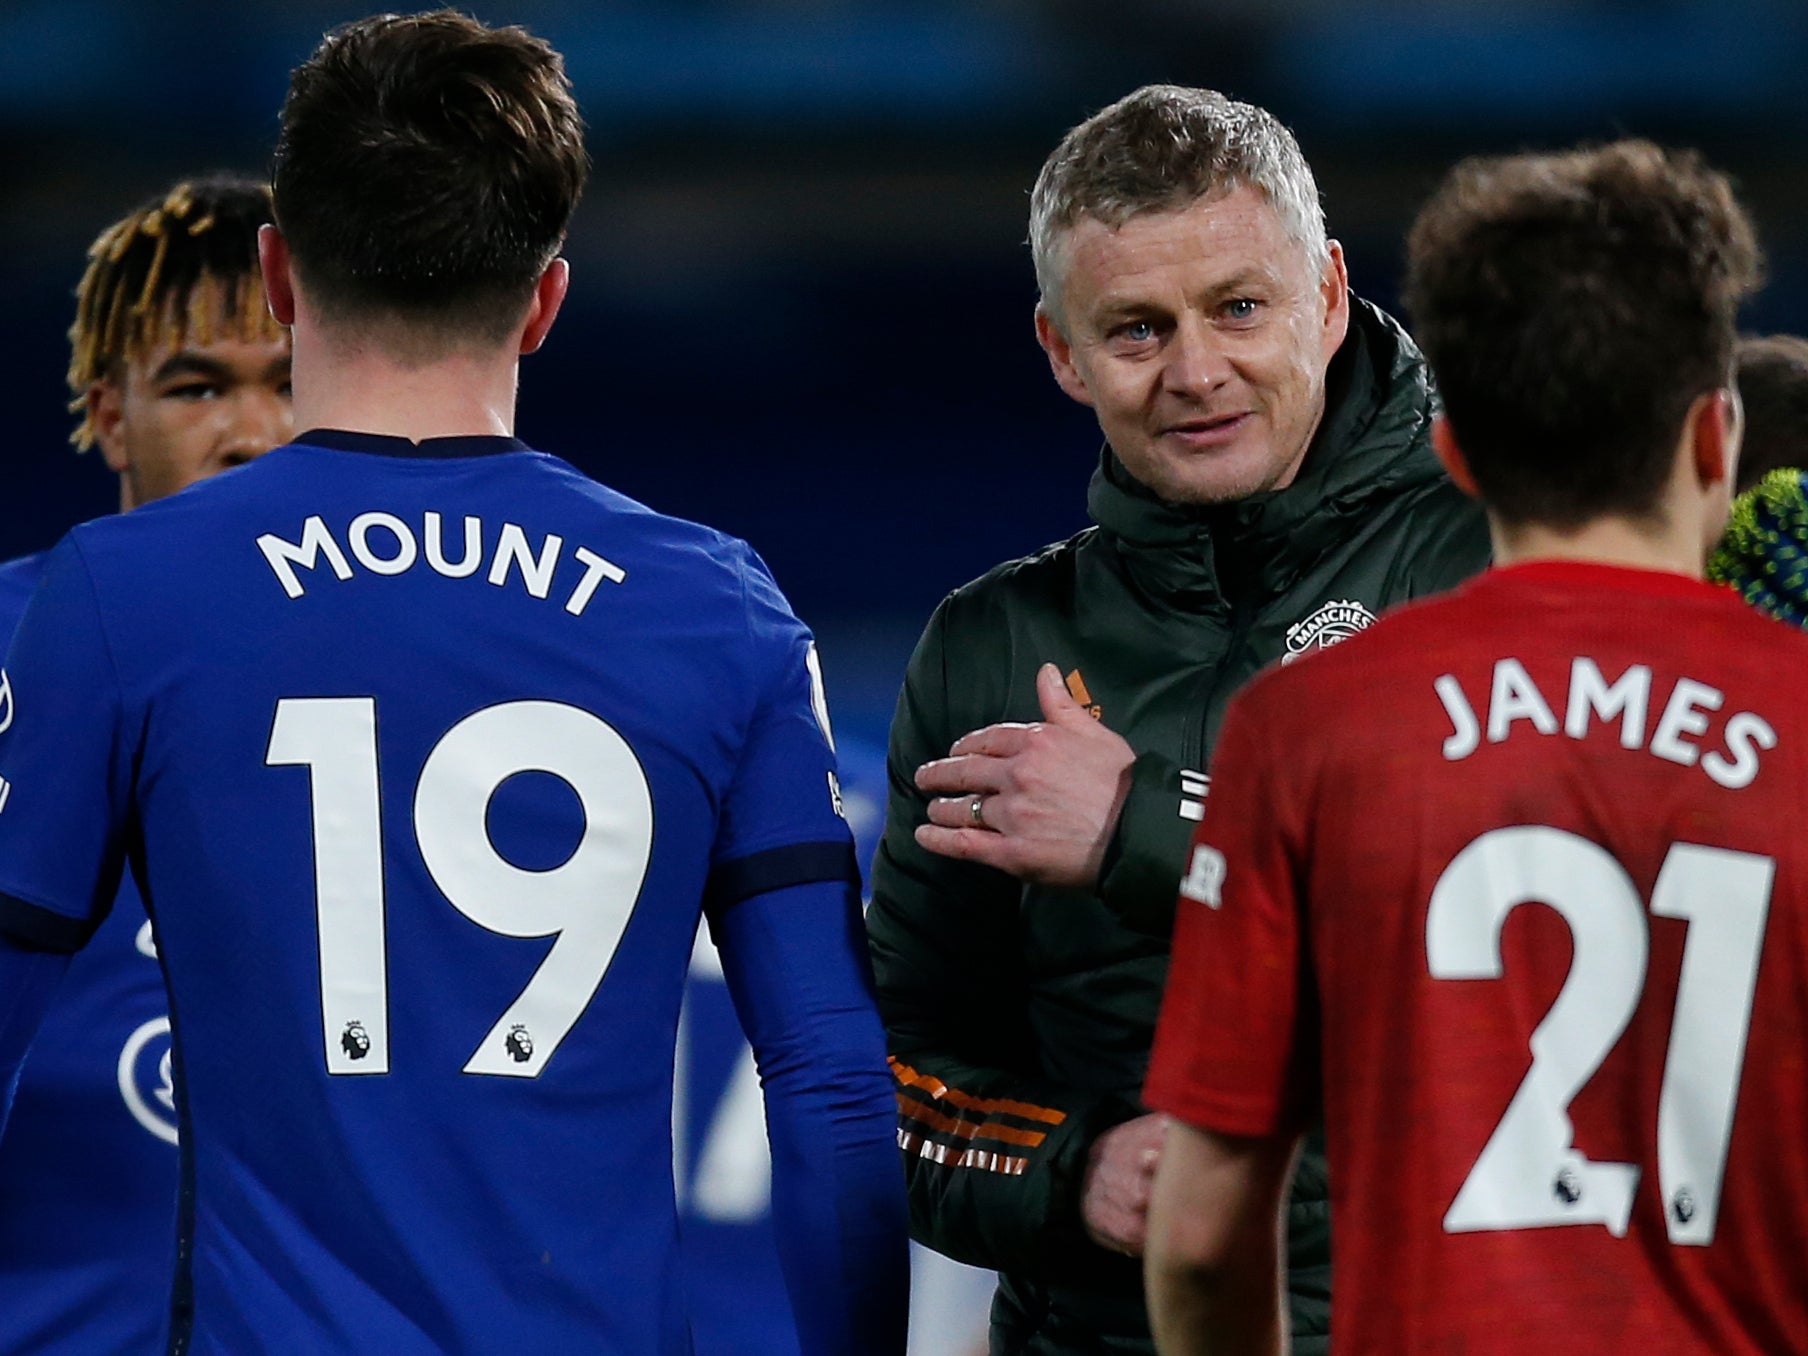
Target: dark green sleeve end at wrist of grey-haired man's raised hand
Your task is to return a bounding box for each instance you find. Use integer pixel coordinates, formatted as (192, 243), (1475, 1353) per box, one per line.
(1099, 752), (1204, 940)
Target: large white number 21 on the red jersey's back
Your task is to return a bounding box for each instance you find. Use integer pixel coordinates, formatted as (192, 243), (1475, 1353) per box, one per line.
(1425, 824), (1775, 1246)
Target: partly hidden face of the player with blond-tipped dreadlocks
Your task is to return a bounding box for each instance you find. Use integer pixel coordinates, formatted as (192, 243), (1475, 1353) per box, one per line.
(89, 301), (295, 508)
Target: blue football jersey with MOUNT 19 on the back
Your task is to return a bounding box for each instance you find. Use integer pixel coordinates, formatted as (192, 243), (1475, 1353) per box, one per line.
(0, 432), (857, 1356)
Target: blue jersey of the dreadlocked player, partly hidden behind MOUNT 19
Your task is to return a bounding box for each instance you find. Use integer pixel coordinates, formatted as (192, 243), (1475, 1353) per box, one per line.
(0, 553), (175, 1356)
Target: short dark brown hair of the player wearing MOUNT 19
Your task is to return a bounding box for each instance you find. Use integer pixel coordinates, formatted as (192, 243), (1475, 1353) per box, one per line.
(275, 9), (589, 342)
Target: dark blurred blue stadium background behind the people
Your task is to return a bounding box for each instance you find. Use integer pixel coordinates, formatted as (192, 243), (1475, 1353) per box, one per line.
(0, 0), (1808, 1356)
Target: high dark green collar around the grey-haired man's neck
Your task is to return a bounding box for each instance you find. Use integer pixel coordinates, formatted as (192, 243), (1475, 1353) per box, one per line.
(1087, 295), (1443, 606)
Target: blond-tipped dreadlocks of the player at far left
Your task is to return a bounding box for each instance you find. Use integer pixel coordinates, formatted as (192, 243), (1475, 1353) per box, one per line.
(69, 177), (282, 452)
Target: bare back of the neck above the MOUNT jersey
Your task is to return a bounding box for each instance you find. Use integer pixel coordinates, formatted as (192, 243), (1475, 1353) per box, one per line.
(293, 342), (515, 443)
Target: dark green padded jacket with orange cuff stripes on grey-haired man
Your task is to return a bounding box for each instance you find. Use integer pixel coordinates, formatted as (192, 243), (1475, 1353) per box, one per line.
(868, 302), (1488, 1356)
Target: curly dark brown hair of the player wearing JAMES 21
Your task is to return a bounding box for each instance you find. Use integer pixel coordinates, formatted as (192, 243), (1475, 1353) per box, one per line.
(1405, 141), (1761, 526)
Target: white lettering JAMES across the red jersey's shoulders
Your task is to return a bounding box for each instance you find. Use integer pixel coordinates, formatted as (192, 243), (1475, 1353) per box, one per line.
(1434, 654), (1777, 790)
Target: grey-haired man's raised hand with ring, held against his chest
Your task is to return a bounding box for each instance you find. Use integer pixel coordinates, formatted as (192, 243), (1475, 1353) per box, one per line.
(917, 664), (1135, 890)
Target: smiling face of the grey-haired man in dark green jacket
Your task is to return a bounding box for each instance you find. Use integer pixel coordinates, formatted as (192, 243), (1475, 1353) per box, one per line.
(1036, 186), (1349, 504)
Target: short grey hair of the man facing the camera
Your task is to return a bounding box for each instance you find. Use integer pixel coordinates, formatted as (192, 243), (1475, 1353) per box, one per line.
(1029, 85), (1331, 327)
